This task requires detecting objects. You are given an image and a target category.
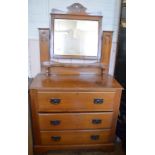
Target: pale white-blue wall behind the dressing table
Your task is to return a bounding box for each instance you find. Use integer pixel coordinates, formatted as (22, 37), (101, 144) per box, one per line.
(28, 0), (121, 77)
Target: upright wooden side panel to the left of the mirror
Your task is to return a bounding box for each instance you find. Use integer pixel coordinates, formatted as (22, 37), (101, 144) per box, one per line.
(39, 28), (50, 63)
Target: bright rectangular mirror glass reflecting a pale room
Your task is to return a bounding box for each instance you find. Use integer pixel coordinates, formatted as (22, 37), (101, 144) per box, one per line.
(54, 19), (98, 57)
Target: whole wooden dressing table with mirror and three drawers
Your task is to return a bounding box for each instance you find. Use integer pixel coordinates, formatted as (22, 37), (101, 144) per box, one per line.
(30, 3), (122, 154)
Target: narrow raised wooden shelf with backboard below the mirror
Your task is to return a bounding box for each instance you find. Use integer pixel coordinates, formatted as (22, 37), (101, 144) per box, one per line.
(42, 60), (107, 75)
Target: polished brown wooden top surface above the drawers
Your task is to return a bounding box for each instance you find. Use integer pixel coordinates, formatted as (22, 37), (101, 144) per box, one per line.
(30, 74), (122, 91)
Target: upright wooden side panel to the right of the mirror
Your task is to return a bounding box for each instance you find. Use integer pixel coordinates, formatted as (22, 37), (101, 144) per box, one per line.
(101, 31), (113, 73)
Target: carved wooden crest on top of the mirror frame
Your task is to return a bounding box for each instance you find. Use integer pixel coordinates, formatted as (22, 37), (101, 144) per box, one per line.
(67, 3), (87, 14)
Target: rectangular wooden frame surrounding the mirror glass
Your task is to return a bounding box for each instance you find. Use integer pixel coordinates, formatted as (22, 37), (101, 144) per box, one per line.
(50, 13), (102, 60)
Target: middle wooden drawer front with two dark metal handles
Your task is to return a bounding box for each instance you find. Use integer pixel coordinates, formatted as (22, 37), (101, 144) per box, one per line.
(39, 112), (113, 130)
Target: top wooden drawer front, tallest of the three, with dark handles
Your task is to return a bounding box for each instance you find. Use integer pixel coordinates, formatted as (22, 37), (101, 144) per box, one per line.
(38, 92), (115, 112)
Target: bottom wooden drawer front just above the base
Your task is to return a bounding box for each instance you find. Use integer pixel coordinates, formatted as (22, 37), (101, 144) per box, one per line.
(41, 130), (110, 145)
